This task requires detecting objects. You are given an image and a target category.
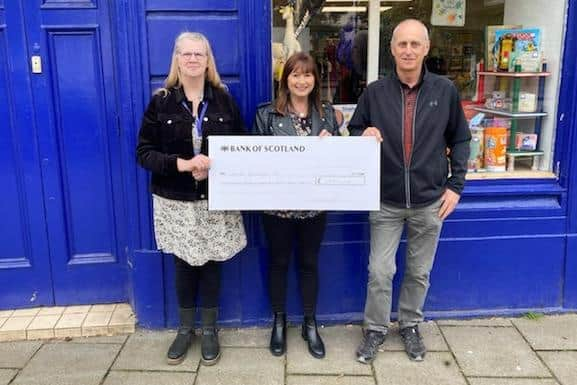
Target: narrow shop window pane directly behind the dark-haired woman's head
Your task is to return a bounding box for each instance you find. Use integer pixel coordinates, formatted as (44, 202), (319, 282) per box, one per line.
(272, 0), (368, 104)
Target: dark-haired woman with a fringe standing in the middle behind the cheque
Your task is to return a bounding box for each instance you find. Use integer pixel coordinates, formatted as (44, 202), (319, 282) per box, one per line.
(254, 52), (339, 358)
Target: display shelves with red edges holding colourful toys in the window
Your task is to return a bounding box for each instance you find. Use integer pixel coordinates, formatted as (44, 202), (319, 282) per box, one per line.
(469, 25), (550, 171)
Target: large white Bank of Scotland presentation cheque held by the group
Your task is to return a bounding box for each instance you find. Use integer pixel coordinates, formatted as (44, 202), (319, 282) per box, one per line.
(208, 136), (381, 210)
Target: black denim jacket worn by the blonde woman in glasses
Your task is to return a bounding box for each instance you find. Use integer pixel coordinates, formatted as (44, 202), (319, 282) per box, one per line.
(136, 83), (246, 201)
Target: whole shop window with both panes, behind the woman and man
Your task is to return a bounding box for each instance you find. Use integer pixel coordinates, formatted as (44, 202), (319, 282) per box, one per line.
(273, 0), (566, 179)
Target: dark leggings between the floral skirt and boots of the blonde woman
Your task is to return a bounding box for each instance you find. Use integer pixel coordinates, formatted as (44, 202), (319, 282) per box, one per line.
(174, 256), (220, 309)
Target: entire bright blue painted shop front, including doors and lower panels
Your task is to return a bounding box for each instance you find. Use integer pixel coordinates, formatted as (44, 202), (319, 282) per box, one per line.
(0, 0), (577, 327)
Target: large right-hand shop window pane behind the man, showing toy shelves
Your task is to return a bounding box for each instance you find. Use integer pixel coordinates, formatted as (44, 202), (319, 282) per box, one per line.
(378, 0), (565, 174)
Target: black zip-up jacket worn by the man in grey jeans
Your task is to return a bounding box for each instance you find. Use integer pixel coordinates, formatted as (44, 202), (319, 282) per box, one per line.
(348, 69), (471, 207)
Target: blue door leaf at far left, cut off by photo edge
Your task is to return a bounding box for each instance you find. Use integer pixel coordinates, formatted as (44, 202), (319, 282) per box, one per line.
(0, 0), (54, 309)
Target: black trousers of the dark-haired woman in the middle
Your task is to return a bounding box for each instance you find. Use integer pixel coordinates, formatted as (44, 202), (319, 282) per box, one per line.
(263, 213), (327, 317)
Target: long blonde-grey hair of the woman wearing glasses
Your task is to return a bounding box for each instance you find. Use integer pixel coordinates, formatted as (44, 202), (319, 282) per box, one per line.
(154, 32), (225, 96)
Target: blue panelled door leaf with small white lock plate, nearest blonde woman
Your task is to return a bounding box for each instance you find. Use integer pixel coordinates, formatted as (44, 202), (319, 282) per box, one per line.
(18, 0), (127, 305)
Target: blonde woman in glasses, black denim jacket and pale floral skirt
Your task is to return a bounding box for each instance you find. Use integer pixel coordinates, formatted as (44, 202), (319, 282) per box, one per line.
(137, 32), (246, 365)
